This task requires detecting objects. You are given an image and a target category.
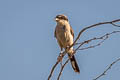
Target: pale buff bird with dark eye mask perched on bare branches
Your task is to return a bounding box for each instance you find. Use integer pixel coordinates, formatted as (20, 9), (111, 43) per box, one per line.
(54, 14), (80, 73)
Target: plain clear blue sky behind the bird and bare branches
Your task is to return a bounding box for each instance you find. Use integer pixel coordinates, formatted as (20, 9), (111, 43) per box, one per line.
(0, 0), (120, 80)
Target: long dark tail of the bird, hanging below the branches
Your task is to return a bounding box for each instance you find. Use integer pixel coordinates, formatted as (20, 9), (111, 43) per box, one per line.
(68, 54), (80, 73)
